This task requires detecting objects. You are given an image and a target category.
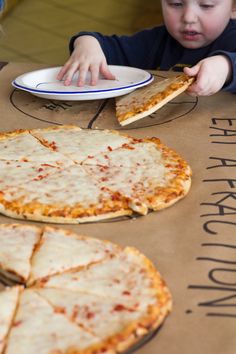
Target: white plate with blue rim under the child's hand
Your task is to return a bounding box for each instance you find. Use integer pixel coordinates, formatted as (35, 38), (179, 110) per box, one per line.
(12, 65), (153, 101)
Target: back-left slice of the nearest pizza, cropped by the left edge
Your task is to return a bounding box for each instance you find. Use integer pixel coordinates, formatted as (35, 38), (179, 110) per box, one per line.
(0, 224), (41, 283)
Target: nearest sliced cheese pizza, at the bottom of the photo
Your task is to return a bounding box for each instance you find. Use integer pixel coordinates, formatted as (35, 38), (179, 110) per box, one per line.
(0, 224), (172, 354)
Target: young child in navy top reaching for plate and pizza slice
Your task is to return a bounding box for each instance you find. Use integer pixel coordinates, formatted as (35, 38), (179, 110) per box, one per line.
(58, 0), (236, 96)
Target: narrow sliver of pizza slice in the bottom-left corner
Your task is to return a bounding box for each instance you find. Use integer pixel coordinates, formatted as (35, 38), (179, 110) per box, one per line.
(0, 286), (23, 354)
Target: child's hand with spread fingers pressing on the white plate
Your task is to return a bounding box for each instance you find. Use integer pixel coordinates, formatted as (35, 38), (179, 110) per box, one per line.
(57, 36), (115, 86)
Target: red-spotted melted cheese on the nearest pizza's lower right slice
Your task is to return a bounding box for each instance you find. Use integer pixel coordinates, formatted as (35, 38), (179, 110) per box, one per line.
(37, 288), (157, 339)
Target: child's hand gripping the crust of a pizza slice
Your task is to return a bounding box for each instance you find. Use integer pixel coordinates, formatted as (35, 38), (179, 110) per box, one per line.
(184, 55), (232, 96)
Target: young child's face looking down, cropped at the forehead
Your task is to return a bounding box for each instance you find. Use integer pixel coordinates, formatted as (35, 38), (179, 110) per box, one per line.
(162, 0), (233, 49)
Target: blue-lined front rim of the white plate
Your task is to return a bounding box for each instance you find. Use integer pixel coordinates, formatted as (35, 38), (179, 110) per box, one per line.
(12, 73), (154, 95)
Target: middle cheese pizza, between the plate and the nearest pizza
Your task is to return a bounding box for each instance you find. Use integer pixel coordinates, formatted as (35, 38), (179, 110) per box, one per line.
(0, 125), (191, 223)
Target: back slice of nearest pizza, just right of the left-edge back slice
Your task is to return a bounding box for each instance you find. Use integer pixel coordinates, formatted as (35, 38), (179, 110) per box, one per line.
(28, 227), (119, 284)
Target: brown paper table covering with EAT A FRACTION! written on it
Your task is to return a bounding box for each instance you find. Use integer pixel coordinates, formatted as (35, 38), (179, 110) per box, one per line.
(0, 63), (236, 354)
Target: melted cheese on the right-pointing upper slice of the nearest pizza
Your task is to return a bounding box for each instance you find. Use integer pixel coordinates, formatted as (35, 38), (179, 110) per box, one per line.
(40, 249), (157, 301)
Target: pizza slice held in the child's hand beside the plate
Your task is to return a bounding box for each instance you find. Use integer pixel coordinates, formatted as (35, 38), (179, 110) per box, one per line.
(116, 74), (194, 126)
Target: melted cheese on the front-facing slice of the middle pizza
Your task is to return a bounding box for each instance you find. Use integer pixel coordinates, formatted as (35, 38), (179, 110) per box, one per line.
(4, 165), (108, 208)
